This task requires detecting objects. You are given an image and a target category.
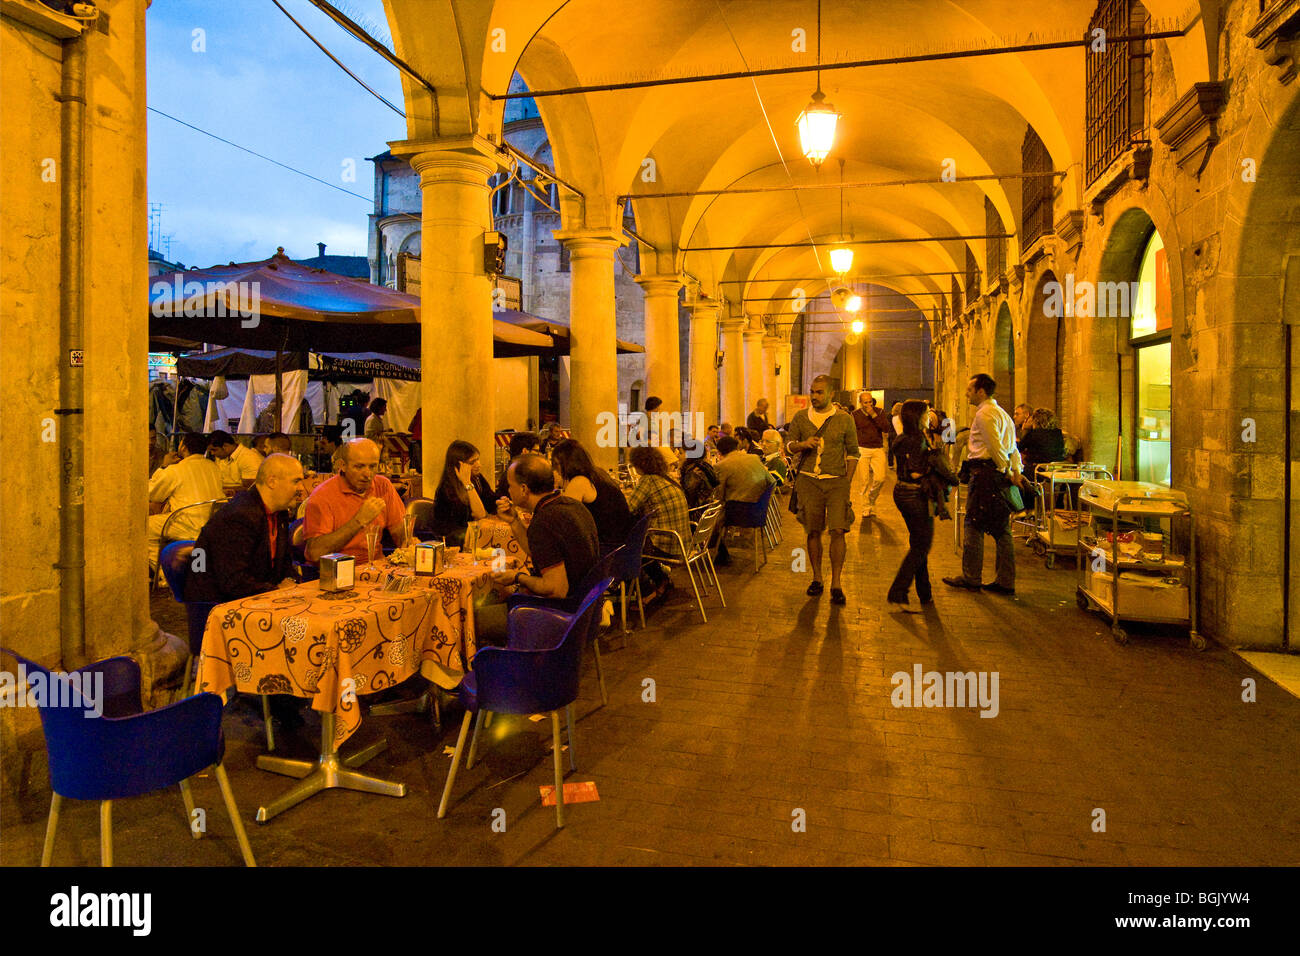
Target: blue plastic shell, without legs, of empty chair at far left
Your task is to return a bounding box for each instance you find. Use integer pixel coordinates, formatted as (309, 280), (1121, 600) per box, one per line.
(0, 648), (225, 800)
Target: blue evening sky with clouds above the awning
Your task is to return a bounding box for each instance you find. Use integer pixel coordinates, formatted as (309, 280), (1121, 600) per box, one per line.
(146, 0), (406, 267)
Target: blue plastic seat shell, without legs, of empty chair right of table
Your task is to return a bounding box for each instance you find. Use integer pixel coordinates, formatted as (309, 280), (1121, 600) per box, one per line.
(475, 578), (614, 714)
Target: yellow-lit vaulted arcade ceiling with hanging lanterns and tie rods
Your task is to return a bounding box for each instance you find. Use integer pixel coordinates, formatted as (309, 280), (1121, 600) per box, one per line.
(385, 0), (1217, 321)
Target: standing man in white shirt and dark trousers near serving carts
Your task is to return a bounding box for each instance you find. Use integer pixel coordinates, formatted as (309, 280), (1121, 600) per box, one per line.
(944, 372), (1024, 596)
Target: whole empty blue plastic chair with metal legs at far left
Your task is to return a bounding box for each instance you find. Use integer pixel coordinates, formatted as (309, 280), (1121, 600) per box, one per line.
(0, 648), (257, 866)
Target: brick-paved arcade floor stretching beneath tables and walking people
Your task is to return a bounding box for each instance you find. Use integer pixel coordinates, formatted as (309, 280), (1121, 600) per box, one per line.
(0, 478), (1300, 866)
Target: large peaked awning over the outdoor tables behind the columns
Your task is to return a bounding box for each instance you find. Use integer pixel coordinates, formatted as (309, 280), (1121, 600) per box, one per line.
(150, 252), (555, 358)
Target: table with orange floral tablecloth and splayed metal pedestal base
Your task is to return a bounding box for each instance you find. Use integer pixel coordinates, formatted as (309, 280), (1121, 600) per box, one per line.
(198, 562), (491, 823)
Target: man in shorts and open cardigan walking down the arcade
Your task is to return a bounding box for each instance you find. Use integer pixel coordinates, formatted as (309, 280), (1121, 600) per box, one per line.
(785, 375), (858, 605)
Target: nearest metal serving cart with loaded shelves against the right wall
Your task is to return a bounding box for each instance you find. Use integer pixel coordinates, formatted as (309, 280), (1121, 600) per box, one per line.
(1076, 480), (1205, 650)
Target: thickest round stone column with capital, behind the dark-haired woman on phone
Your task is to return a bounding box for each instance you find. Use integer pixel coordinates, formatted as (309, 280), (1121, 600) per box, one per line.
(390, 137), (497, 475)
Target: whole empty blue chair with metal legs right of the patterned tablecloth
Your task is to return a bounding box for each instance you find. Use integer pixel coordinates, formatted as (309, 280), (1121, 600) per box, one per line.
(438, 578), (614, 829)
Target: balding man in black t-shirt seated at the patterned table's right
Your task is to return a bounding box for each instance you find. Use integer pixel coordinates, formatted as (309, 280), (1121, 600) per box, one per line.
(475, 455), (601, 644)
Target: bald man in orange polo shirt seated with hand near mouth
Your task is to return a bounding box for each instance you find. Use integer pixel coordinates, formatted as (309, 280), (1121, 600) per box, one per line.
(303, 438), (408, 564)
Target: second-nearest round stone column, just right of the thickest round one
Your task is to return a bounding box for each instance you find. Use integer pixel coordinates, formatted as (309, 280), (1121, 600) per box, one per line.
(555, 229), (624, 468)
